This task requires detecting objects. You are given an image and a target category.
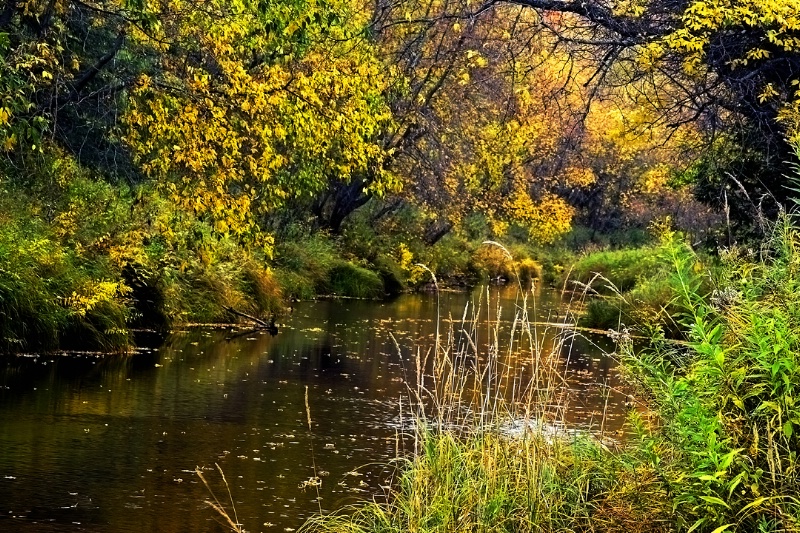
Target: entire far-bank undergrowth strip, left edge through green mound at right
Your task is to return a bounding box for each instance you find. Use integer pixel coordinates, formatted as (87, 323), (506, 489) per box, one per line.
(0, 142), (704, 352)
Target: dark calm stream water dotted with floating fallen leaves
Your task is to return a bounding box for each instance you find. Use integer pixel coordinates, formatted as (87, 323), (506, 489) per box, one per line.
(0, 288), (624, 532)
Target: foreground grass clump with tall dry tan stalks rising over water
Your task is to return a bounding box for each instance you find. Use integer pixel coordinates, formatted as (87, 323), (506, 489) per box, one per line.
(303, 248), (665, 532)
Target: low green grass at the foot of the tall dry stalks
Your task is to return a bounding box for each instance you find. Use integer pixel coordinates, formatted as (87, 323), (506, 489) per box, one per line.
(303, 431), (667, 533)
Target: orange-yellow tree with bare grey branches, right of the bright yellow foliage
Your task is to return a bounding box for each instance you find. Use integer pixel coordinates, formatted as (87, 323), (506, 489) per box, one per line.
(332, 1), (592, 244)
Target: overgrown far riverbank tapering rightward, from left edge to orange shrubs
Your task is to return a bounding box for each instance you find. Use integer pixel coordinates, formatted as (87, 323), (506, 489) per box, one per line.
(0, 175), (620, 352)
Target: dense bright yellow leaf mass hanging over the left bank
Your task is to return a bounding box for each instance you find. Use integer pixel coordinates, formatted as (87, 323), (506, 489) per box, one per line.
(124, 0), (398, 236)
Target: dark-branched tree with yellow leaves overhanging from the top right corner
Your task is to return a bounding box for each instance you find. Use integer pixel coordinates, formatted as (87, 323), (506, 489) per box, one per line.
(477, 0), (800, 222)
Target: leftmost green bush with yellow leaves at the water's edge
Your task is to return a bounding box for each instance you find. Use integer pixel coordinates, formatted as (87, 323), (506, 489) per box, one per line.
(0, 202), (128, 351)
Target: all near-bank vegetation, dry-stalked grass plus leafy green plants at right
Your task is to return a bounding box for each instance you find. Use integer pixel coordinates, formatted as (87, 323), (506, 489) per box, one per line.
(296, 219), (800, 533)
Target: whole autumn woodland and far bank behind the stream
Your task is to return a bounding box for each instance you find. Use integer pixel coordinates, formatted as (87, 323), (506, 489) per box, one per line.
(0, 0), (800, 351)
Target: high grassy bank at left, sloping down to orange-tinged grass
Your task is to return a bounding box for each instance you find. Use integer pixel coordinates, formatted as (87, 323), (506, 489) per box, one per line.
(0, 177), (288, 352)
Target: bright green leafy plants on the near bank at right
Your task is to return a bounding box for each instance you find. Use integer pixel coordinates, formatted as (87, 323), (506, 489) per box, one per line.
(623, 220), (800, 532)
